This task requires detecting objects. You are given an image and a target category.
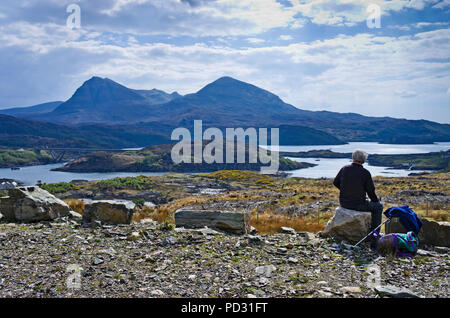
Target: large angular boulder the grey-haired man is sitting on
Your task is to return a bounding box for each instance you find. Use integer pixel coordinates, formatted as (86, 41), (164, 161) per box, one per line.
(322, 207), (371, 243)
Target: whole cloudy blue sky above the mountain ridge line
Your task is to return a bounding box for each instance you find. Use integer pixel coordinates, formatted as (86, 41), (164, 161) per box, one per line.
(0, 0), (450, 123)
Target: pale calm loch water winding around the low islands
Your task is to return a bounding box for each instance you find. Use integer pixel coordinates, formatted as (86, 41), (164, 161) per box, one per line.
(0, 142), (450, 185)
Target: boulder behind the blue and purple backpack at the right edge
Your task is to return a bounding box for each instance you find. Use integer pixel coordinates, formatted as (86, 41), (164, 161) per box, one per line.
(386, 218), (450, 247)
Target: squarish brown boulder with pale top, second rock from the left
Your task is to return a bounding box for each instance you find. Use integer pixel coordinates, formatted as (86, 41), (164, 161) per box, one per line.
(83, 200), (136, 224)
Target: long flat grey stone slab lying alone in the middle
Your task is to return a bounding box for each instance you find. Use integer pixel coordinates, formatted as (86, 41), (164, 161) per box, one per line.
(175, 209), (249, 234)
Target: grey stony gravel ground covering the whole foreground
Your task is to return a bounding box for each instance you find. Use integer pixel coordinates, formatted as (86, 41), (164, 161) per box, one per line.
(0, 220), (450, 298)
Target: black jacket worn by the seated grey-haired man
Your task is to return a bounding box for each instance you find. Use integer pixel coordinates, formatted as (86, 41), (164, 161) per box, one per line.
(333, 163), (378, 209)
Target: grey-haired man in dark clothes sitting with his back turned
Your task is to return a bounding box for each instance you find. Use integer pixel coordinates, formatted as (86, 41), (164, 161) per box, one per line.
(333, 150), (383, 249)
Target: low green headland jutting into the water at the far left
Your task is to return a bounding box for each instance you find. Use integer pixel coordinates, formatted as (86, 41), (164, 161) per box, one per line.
(0, 149), (52, 168)
